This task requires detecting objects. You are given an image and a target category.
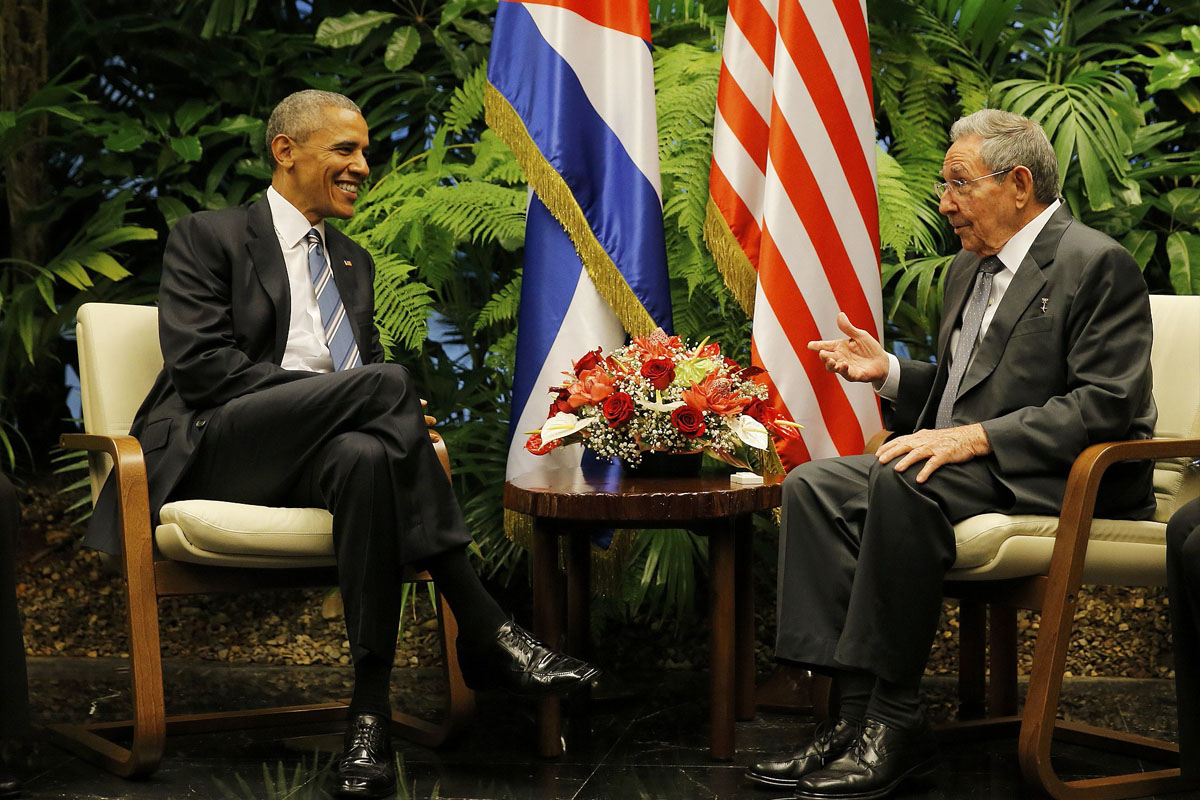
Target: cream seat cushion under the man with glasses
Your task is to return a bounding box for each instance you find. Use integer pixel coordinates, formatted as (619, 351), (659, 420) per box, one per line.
(947, 513), (1166, 585)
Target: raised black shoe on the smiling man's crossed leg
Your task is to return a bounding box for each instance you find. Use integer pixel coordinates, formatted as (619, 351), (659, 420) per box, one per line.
(460, 621), (600, 697)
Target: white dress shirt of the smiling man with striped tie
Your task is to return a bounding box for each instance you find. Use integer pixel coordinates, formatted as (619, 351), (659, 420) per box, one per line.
(266, 186), (334, 372)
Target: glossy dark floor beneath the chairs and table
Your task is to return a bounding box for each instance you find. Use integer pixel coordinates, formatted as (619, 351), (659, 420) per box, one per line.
(9, 658), (1200, 800)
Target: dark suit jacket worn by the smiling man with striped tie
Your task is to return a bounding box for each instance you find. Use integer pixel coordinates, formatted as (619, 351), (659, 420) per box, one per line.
(84, 198), (383, 553)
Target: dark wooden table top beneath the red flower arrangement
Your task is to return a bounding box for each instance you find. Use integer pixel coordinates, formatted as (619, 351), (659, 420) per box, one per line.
(504, 469), (784, 522)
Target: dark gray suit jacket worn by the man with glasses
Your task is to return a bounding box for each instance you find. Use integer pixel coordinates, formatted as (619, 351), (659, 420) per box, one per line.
(886, 205), (1158, 517)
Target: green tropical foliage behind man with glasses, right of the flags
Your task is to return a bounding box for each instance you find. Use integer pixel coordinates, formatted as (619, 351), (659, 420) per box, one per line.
(868, 0), (1200, 355)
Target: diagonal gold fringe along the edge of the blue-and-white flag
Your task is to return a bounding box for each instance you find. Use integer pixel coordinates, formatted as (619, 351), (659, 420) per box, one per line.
(484, 84), (658, 336)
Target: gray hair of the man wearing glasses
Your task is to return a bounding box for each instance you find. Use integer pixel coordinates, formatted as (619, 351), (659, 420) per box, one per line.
(950, 108), (1058, 205)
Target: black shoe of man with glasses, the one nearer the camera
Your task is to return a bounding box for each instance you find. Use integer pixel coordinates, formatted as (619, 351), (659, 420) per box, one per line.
(796, 718), (937, 800)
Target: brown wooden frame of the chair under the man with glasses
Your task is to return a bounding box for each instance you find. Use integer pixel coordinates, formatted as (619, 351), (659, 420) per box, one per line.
(946, 439), (1200, 800)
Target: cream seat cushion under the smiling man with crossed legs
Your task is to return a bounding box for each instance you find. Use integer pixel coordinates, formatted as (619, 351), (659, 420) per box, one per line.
(155, 500), (335, 567)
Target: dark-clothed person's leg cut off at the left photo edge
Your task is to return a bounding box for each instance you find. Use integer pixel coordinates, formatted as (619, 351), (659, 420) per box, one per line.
(0, 474), (29, 800)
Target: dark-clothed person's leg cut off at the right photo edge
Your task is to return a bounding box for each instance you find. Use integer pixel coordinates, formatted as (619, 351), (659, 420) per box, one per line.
(1166, 500), (1200, 783)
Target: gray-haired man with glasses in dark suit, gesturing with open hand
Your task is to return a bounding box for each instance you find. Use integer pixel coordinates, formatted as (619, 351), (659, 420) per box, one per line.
(748, 109), (1157, 800)
